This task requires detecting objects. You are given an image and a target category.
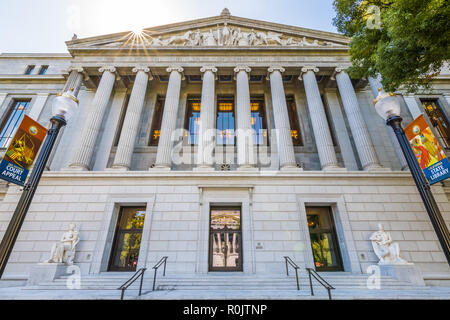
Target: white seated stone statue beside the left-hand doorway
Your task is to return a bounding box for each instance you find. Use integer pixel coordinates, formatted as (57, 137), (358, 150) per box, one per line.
(45, 223), (80, 265)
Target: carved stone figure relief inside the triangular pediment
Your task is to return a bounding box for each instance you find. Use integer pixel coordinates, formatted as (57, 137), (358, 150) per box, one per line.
(137, 23), (342, 47)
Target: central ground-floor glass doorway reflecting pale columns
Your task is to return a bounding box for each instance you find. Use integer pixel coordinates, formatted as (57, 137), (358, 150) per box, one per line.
(209, 207), (242, 271)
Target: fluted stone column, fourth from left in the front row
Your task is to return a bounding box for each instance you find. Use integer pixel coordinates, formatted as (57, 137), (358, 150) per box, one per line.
(196, 66), (217, 170)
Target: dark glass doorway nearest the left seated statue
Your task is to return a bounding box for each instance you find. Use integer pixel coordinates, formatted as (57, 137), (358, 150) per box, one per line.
(108, 207), (145, 271)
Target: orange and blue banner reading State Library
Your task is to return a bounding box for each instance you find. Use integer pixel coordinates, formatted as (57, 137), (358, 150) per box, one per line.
(405, 114), (450, 184)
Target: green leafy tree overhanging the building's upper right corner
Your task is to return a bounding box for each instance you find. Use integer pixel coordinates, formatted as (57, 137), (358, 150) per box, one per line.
(333, 0), (450, 92)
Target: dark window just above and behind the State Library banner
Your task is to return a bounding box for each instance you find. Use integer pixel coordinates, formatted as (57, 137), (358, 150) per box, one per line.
(421, 99), (450, 148)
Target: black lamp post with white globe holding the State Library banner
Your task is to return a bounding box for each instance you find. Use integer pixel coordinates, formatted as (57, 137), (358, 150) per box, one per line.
(374, 89), (450, 265)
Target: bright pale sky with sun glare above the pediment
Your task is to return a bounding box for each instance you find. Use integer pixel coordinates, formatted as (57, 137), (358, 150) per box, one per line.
(0, 0), (336, 53)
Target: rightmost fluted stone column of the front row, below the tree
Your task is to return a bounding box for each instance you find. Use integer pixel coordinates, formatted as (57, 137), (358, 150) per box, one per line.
(336, 68), (382, 170)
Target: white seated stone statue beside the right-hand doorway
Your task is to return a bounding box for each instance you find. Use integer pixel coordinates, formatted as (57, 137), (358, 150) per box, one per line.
(370, 223), (407, 264)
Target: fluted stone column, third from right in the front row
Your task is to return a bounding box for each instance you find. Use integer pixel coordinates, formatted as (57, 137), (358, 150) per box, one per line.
(268, 67), (297, 170)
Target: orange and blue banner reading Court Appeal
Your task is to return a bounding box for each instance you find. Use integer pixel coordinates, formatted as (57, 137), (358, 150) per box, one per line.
(0, 115), (47, 186)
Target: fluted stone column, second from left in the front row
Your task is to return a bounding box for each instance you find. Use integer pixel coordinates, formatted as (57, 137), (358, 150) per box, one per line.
(112, 67), (153, 170)
